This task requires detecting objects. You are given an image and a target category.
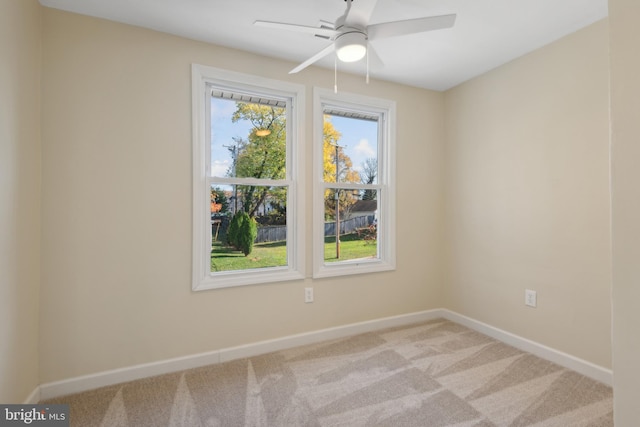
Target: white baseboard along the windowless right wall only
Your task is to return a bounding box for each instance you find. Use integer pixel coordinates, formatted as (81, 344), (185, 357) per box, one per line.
(441, 309), (613, 386)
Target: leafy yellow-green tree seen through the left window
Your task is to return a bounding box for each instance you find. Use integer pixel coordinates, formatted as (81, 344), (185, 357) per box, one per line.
(232, 102), (286, 217)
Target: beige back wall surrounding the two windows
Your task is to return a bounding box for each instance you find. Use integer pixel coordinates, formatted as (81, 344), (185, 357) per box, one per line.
(40, 9), (444, 383)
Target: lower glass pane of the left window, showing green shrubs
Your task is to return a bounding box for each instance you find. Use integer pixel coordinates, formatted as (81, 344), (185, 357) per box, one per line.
(211, 185), (287, 272)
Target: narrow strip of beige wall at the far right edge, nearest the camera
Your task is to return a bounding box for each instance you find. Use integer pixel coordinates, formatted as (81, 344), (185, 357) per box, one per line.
(609, 0), (640, 426)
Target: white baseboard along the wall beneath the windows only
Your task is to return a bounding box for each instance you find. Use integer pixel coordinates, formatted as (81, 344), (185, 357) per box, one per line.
(39, 310), (442, 400)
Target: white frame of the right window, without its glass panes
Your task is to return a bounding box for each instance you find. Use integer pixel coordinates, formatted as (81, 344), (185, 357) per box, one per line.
(313, 87), (396, 278)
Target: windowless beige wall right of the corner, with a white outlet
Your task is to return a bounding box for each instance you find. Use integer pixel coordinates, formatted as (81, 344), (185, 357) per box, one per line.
(445, 21), (611, 367)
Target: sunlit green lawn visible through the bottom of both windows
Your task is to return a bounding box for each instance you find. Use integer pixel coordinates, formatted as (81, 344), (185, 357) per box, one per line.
(211, 234), (377, 271)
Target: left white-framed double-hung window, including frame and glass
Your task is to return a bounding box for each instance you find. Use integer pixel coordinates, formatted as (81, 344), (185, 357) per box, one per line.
(192, 65), (304, 290)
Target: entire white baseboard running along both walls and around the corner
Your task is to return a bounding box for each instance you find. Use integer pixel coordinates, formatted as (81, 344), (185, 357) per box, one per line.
(38, 309), (613, 400)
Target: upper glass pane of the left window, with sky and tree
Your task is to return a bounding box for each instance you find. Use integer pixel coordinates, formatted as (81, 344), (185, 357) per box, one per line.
(211, 97), (287, 179)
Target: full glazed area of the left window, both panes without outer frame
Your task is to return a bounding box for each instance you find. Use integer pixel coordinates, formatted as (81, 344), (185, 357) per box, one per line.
(210, 94), (288, 272)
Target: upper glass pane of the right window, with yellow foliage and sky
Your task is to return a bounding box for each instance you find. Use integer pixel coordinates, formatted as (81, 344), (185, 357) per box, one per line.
(323, 114), (379, 184)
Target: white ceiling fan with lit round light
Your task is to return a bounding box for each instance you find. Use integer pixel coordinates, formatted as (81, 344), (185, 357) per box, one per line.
(254, 0), (456, 74)
